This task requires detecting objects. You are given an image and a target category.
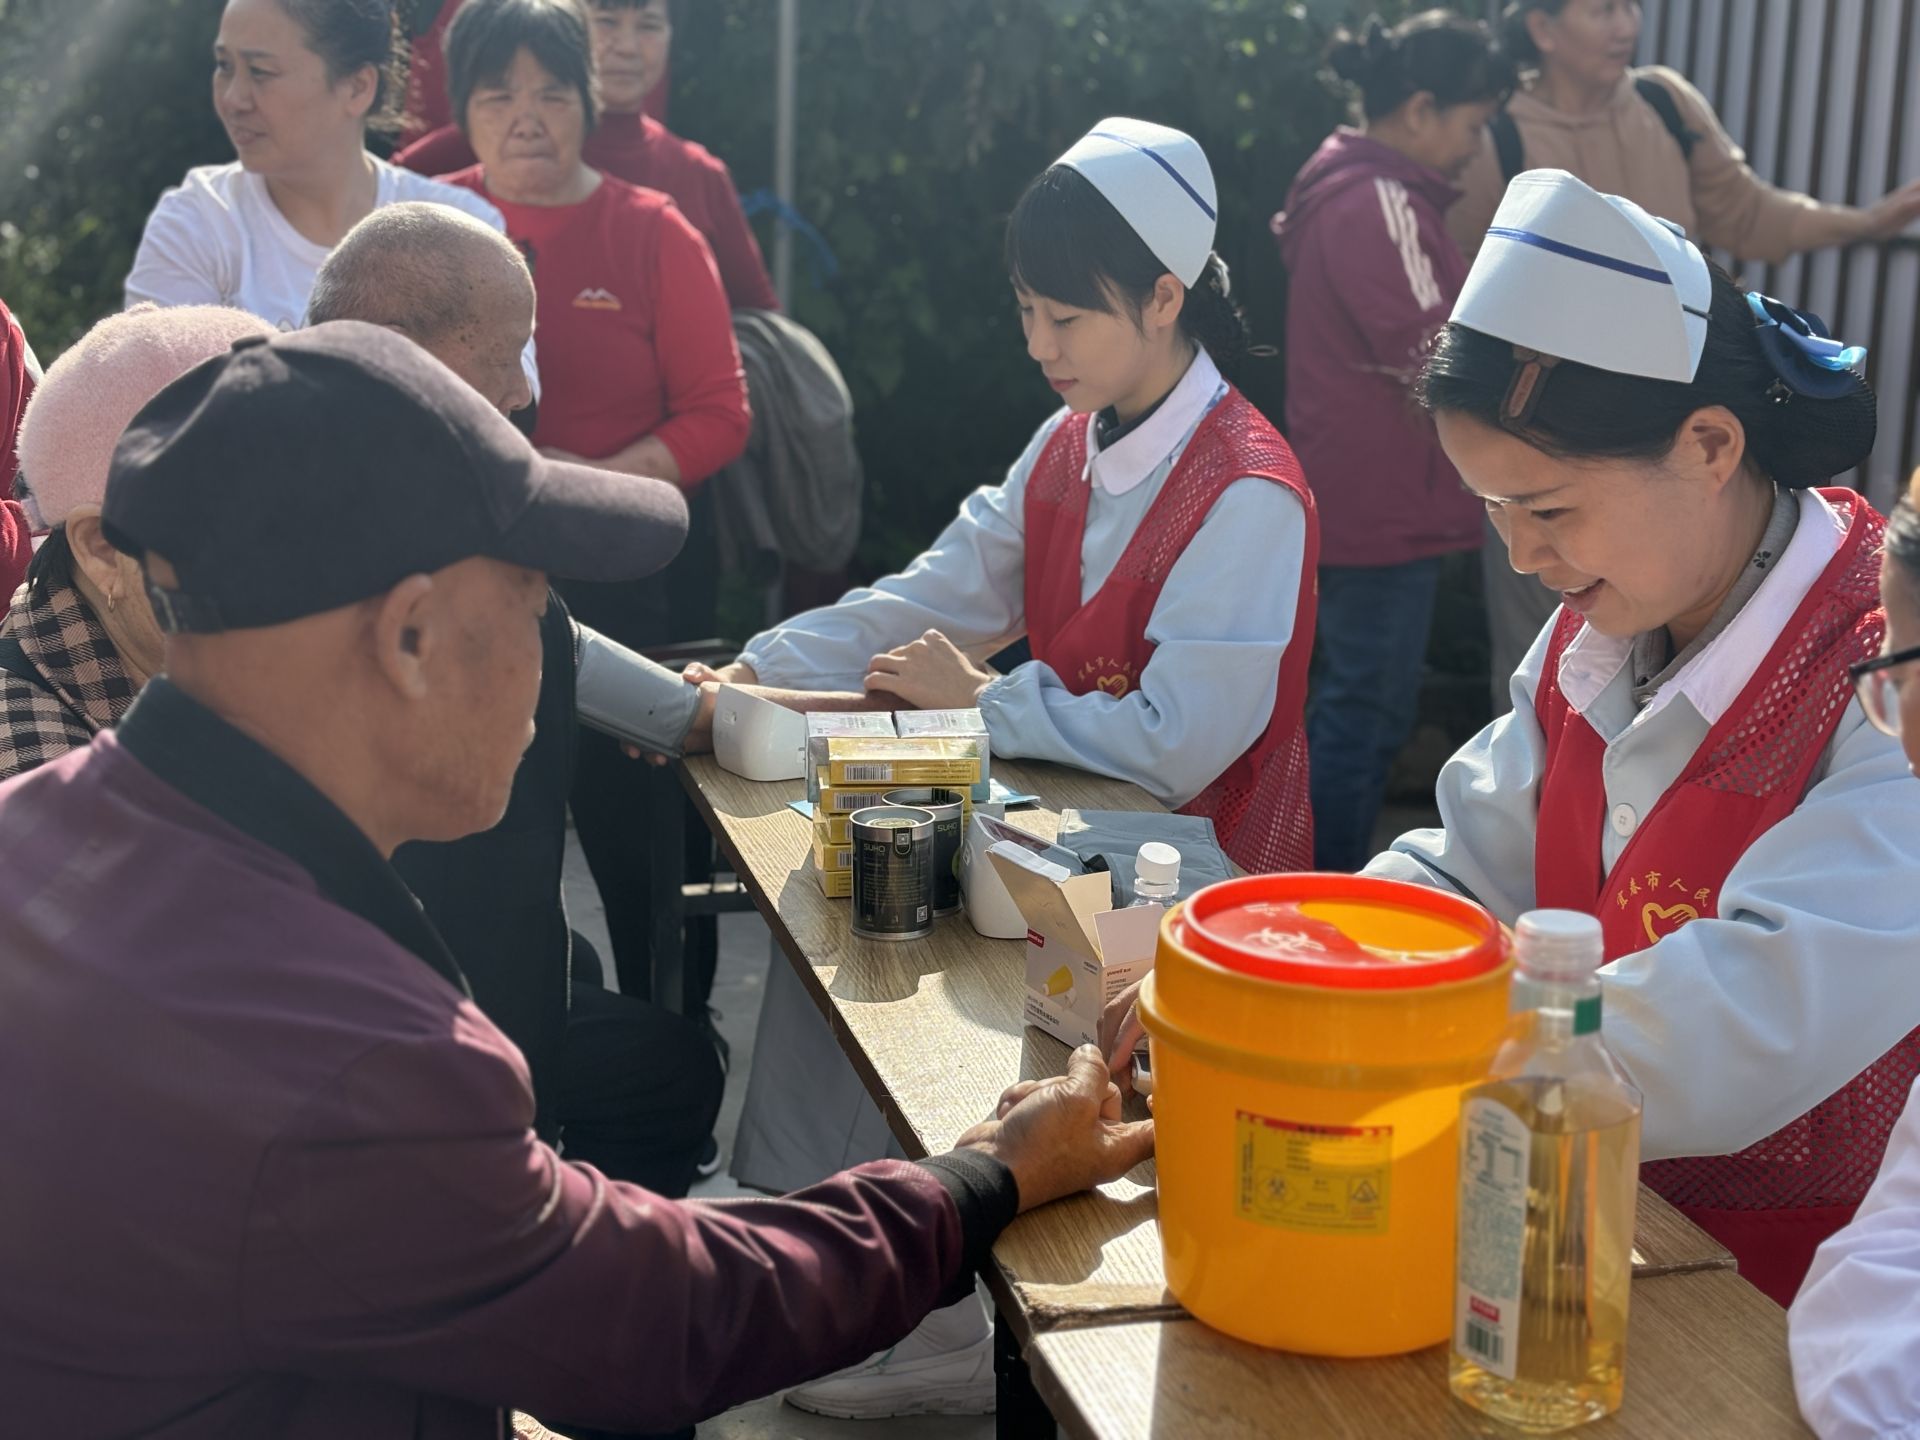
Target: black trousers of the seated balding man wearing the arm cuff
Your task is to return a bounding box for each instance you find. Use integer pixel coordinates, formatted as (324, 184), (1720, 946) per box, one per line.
(559, 981), (726, 1200)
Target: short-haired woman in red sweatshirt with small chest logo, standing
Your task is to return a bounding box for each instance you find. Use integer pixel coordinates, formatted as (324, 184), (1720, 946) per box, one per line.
(445, 0), (749, 998)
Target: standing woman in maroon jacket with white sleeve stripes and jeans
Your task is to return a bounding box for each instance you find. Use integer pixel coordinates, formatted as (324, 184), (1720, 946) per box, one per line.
(1273, 10), (1515, 870)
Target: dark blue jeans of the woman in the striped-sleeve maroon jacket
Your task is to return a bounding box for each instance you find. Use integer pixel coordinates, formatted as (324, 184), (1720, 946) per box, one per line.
(1308, 557), (1440, 872)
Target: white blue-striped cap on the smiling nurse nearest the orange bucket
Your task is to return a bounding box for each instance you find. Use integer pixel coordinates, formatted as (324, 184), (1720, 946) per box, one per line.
(1453, 171), (1713, 384)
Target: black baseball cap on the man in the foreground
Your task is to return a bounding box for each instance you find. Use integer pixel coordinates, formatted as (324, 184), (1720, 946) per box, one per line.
(100, 321), (687, 634)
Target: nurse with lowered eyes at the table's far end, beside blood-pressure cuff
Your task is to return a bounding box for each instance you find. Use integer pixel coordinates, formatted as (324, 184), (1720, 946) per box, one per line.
(695, 119), (1317, 870)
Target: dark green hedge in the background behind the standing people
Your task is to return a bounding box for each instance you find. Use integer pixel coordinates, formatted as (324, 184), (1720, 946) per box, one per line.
(0, 0), (1405, 572)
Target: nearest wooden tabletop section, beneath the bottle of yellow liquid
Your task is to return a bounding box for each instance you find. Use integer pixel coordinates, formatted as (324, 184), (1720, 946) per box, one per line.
(1027, 1269), (1811, 1440)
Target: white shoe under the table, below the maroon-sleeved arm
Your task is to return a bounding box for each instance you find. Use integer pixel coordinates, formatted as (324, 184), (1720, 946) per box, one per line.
(787, 1296), (995, 1421)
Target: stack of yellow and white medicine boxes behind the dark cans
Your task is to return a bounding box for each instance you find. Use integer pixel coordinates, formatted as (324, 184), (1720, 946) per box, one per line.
(806, 712), (987, 899)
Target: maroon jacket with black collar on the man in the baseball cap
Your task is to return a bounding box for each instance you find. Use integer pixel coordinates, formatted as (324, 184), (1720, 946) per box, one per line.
(0, 680), (1018, 1440)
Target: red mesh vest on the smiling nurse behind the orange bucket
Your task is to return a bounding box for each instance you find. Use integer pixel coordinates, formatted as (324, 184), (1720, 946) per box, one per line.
(1534, 490), (1920, 1306)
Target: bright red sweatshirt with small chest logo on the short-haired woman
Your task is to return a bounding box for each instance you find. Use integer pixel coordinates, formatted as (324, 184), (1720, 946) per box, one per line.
(442, 165), (751, 490)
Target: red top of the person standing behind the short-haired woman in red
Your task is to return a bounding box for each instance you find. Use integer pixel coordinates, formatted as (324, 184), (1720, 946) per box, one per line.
(394, 112), (780, 309)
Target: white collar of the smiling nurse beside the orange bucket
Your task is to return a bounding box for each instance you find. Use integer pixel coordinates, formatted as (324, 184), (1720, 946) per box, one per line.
(1559, 490), (1847, 726)
